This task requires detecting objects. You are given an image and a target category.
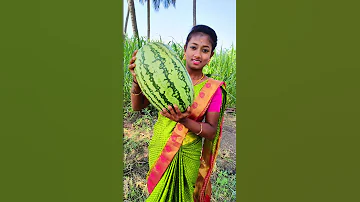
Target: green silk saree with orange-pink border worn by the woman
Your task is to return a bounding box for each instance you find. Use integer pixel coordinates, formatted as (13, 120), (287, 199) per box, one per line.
(146, 78), (226, 202)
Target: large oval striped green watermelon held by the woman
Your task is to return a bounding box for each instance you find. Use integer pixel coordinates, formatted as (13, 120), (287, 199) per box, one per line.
(135, 42), (194, 112)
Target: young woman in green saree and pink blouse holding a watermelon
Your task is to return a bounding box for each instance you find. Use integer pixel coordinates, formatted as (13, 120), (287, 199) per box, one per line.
(129, 25), (226, 202)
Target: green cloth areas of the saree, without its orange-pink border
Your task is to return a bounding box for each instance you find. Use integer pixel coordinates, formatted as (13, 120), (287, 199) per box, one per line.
(146, 80), (226, 202)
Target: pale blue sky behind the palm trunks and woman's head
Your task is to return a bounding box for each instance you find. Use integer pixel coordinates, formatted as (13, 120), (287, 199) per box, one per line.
(123, 0), (236, 49)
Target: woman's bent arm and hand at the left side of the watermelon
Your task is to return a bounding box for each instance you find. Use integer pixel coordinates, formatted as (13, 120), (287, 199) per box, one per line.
(129, 50), (149, 111)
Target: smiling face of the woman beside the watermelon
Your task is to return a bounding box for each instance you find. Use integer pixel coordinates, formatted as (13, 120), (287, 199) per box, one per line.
(185, 33), (214, 70)
